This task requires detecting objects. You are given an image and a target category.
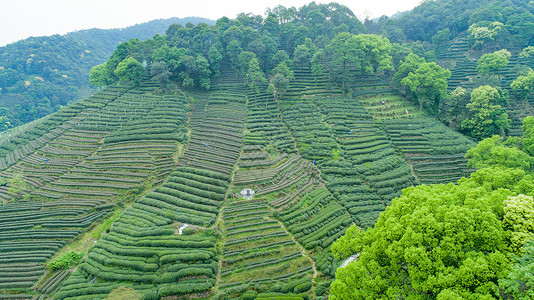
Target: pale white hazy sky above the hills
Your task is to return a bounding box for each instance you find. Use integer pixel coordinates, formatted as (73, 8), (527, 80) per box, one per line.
(0, 0), (421, 46)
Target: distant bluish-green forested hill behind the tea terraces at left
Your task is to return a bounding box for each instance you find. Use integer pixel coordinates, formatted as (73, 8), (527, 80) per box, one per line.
(0, 17), (213, 130)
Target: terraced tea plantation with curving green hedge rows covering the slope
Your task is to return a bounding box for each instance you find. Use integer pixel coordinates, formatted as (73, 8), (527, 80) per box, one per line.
(0, 63), (473, 299)
